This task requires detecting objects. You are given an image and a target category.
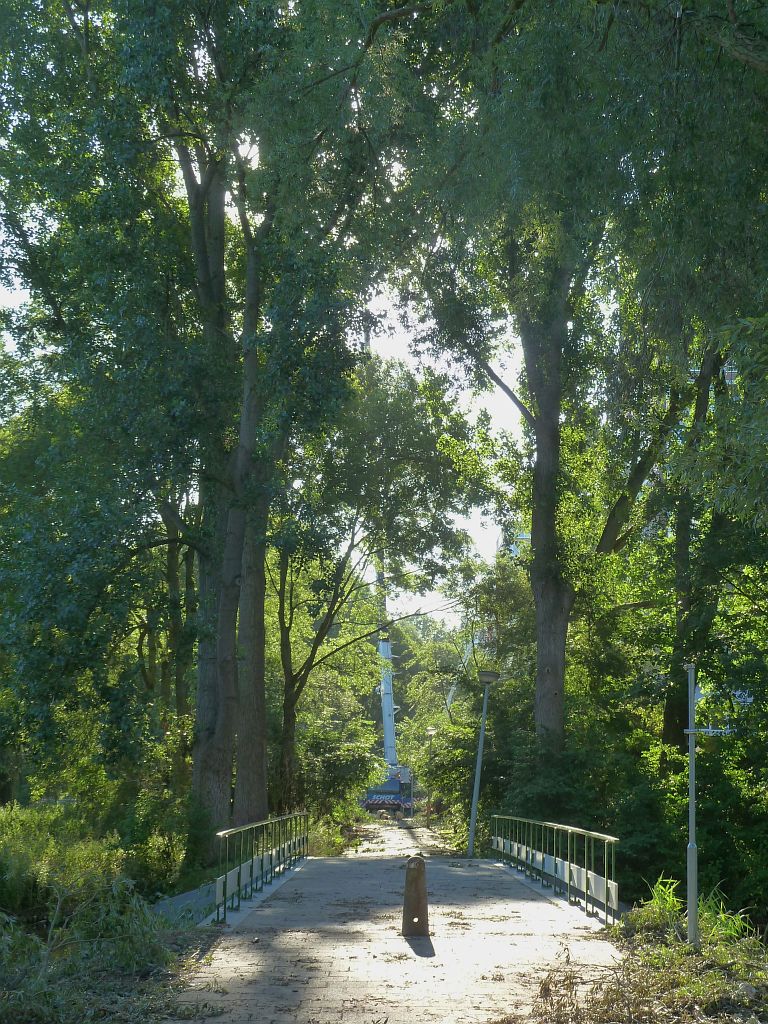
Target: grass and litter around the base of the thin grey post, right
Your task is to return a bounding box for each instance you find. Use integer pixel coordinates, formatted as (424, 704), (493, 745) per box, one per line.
(535, 879), (768, 1024)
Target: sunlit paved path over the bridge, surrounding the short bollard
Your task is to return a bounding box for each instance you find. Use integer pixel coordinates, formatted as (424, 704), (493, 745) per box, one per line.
(174, 823), (617, 1024)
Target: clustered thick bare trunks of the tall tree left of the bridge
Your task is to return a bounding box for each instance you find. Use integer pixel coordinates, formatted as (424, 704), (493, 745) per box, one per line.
(175, 146), (280, 827)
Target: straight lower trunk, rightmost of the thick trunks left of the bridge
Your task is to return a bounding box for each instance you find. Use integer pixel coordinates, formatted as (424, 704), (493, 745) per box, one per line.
(234, 512), (269, 824)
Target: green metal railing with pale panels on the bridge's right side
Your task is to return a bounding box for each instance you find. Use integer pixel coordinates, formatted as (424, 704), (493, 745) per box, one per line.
(492, 814), (618, 925)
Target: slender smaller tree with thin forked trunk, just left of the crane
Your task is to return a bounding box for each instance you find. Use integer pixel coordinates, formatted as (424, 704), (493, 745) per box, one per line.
(271, 358), (472, 807)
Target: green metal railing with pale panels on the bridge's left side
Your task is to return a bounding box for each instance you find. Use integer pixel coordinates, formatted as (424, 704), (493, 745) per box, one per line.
(216, 811), (309, 921)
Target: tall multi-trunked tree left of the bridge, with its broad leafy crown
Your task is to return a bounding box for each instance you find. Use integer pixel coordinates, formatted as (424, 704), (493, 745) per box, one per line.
(2, 0), (428, 825)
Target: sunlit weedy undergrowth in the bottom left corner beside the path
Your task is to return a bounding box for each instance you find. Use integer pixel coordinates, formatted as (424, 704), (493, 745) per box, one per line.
(0, 807), (201, 1024)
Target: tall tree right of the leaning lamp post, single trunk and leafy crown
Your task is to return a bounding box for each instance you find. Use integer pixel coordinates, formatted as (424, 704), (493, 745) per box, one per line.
(391, 2), (761, 745)
